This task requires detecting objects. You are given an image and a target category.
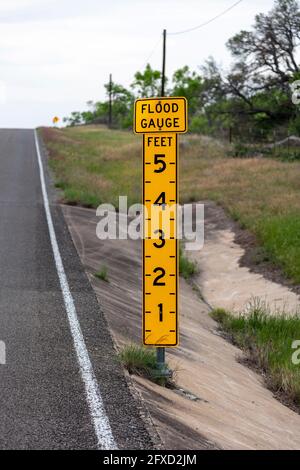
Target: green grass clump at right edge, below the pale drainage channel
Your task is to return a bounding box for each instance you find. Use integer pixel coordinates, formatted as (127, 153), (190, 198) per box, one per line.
(211, 305), (300, 408)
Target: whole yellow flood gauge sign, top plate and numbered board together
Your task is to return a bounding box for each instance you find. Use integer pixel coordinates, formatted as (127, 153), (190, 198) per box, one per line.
(135, 97), (187, 347)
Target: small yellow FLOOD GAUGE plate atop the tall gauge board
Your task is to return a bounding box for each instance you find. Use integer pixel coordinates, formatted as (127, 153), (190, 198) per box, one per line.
(134, 97), (187, 134)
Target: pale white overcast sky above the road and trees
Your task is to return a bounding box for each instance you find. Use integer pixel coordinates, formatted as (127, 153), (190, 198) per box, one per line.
(0, 0), (274, 128)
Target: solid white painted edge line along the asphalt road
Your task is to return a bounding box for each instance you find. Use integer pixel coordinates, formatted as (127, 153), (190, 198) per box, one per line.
(34, 130), (117, 450)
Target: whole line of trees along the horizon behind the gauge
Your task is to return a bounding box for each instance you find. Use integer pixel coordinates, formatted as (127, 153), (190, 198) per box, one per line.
(64, 0), (300, 140)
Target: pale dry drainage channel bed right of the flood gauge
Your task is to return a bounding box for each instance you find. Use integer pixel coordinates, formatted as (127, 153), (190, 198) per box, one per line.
(190, 201), (300, 314)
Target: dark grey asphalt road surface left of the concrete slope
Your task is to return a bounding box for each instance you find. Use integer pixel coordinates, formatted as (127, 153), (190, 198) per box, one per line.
(0, 130), (152, 449)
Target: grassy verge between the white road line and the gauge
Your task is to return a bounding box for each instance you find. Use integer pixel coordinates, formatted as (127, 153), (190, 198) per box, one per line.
(41, 126), (141, 207)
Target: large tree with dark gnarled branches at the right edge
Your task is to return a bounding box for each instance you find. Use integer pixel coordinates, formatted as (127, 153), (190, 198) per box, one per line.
(200, 0), (300, 139)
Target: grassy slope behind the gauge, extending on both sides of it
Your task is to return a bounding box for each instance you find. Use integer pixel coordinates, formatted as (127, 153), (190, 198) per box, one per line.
(40, 126), (300, 284)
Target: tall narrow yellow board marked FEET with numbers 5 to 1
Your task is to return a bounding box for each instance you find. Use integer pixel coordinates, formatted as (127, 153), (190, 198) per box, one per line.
(143, 134), (178, 346)
